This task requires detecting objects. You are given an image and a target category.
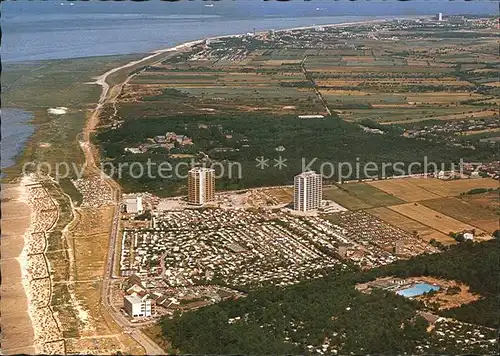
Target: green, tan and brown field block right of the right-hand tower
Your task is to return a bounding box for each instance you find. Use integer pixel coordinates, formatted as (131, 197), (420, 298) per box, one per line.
(323, 178), (499, 245)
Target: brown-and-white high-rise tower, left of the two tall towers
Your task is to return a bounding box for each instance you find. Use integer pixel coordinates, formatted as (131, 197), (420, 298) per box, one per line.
(188, 167), (215, 205)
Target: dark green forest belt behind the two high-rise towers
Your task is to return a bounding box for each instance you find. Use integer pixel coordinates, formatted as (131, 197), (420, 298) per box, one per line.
(97, 114), (496, 196)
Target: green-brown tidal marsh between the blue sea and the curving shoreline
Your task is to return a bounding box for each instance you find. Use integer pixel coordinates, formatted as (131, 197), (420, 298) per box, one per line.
(2, 55), (140, 180)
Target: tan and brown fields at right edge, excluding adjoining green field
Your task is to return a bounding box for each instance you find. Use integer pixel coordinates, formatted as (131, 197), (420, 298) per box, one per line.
(366, 178), (499, 245)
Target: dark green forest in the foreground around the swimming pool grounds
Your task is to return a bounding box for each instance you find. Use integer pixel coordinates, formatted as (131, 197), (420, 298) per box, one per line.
(161, 240), (500, 354)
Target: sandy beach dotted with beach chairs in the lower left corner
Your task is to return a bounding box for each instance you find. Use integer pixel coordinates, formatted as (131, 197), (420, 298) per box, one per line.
(2, 175), (64, 354)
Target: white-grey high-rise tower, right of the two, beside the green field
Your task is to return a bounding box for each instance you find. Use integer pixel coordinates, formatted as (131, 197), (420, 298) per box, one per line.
(293, 171), (323, 211)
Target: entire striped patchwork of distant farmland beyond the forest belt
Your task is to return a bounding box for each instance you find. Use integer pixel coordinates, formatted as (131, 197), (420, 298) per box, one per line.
(122, 21), (498, 124)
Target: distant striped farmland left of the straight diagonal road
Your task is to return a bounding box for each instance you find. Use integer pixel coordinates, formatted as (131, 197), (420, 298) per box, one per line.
(122, 48), (326, 114)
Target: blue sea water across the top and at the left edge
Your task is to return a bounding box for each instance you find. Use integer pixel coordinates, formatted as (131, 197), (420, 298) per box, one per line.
(0, 0), (498, 169)
